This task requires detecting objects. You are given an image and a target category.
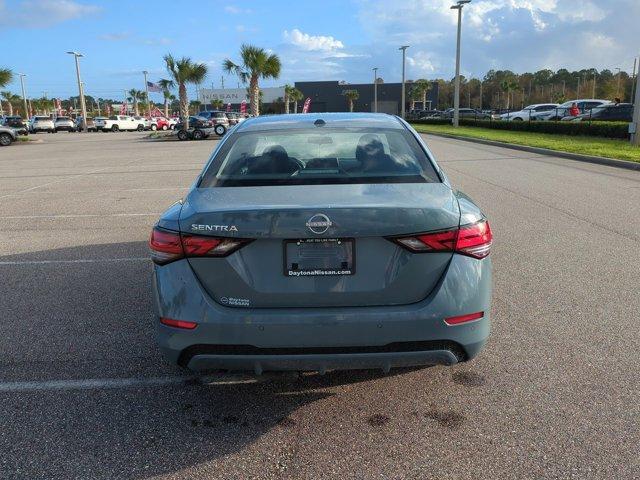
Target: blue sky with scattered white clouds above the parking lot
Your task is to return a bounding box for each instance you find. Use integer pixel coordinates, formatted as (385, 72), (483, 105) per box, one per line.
(0, 0), (640, 101)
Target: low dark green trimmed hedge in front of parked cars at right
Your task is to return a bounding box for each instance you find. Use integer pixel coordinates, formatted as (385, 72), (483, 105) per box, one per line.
(412, 118), (629, 139)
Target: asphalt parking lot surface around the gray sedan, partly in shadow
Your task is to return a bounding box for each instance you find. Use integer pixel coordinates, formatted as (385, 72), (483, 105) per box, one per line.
(0, 133), (640, 479)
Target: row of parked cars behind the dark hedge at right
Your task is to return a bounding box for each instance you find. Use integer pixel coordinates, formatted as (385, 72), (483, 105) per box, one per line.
(409, 98), (633, 122)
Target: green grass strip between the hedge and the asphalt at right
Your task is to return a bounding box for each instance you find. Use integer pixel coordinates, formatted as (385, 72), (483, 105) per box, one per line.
(413, 125), (640, 162)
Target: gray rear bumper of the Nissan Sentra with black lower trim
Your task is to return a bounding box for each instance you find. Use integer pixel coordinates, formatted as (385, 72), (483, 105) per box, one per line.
(153, 255), (491, 373)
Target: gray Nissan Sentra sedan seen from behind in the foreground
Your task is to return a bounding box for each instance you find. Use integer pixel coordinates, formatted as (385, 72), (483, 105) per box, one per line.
(149, 113), (492, 374)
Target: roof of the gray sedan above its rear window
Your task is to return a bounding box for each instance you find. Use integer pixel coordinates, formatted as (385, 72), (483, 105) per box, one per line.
(235, 113), (405, 132)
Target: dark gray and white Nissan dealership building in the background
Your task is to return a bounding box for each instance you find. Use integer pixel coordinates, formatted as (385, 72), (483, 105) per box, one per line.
(198, 81), (438, 115)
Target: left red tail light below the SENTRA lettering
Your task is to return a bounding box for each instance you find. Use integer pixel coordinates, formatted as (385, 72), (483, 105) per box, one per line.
(149, 228), (251, 265)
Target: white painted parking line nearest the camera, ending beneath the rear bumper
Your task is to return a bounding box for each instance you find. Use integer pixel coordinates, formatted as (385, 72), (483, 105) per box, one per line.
(0, 375), (266, 393)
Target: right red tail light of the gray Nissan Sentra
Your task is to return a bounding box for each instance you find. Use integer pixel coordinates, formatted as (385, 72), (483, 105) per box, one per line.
(392, 220), (493, 258)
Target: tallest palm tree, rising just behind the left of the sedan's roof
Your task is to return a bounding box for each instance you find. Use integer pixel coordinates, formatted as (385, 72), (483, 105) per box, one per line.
(222, 44), (281, 117)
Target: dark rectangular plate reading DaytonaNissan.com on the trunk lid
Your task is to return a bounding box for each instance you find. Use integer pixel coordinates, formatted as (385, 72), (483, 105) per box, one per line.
(284, 238), (356, 277)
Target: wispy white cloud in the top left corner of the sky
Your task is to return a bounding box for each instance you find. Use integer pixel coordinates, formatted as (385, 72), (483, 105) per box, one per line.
(0, 0), (102, 28)
